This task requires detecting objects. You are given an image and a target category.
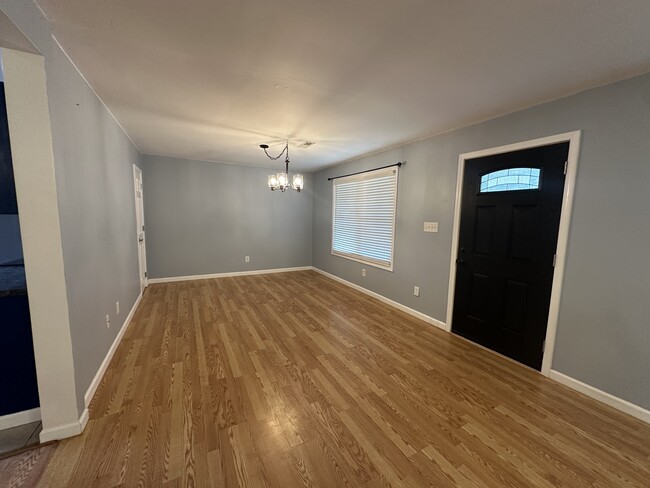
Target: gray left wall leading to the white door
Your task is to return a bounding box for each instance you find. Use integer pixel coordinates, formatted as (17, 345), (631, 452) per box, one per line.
(0, 0), (140, 413)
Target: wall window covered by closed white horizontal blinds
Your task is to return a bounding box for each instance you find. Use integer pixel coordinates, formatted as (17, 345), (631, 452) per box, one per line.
(332, 166), (398, 271)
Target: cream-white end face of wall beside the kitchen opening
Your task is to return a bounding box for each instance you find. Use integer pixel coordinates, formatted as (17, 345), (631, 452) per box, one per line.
(2, 49), (79, 440)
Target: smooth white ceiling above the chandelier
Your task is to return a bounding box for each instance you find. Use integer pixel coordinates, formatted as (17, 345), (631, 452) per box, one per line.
(37, 0), (650, 171)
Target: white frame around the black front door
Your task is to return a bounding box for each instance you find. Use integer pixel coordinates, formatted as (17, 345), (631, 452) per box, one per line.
(446, 130), (581, 376)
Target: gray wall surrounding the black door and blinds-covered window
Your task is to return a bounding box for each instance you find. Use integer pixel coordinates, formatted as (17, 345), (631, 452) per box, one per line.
(313, 75), (650, 409)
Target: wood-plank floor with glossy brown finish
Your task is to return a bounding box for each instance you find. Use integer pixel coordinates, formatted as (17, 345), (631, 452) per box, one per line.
(36, 271), (650, 488)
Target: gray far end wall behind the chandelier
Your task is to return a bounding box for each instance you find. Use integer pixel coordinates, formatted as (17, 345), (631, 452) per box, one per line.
(143, 155), (313, 278)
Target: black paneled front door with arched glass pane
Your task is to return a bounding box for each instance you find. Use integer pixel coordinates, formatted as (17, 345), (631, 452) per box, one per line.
(452, 142), (569, 370)
